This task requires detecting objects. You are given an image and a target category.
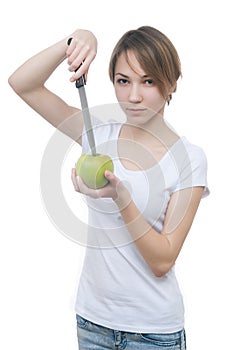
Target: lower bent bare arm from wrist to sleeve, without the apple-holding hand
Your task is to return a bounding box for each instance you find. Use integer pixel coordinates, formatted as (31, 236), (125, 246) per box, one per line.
(117, 187), (204, 277)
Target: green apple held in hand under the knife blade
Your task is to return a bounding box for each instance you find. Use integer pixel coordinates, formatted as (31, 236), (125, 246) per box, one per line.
(76, 153), (114, 189)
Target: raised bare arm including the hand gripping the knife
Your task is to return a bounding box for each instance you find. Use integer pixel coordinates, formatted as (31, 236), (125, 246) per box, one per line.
(9, 30), (97, 142)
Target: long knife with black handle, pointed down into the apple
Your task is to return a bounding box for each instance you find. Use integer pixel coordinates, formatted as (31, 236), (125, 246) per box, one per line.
(67, 38), (97, 156)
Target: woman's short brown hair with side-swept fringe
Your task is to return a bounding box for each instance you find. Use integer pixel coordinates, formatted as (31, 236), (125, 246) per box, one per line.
(109, 26), (182, 102)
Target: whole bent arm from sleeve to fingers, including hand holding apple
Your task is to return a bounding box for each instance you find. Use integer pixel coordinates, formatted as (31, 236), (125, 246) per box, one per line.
(72, 169), (204, 277)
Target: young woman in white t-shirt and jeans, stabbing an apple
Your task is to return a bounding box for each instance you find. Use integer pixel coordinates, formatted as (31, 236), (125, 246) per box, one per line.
(9, 26), (208, 350)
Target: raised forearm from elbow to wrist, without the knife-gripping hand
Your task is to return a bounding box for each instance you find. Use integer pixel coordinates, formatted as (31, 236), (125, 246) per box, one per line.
(9, 39), (67, 95)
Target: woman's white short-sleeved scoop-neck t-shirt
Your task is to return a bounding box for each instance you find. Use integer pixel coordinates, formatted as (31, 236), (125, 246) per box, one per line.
(75, 122), (209, 333)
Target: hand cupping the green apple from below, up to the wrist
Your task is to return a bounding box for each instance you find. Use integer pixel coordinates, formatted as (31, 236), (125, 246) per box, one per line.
(71, 168), (130, 205)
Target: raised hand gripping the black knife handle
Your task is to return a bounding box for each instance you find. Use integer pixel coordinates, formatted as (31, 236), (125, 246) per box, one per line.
(66, 29), (97, 82)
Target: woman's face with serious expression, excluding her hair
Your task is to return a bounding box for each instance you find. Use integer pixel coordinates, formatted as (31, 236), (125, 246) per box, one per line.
(114, 51), (166, 125)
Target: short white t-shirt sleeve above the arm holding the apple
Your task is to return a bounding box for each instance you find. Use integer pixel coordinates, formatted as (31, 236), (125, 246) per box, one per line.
(173, 145), (210, 198)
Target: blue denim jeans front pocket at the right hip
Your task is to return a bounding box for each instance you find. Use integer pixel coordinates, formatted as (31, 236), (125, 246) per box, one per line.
(141, 332), (182, 350)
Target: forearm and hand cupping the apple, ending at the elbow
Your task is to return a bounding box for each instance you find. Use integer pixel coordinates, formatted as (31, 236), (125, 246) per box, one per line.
(72, 169), (172, 276)
